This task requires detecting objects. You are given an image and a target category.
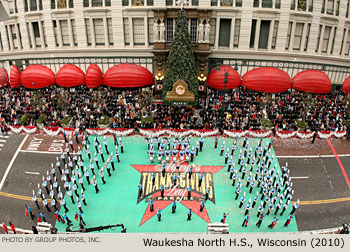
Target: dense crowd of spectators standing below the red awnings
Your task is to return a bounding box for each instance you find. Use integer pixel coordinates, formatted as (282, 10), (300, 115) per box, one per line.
(0, 86), (350, 131)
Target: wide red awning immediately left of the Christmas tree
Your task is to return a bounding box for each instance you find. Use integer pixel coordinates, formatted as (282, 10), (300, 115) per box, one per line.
(103, 64), (153, 88)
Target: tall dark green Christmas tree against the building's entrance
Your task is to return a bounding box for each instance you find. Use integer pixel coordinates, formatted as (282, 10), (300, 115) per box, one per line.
(163, 9), (198, 101)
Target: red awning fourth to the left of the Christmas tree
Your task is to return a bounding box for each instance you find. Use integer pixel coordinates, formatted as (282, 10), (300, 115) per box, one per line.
(21, 65), (55, 88)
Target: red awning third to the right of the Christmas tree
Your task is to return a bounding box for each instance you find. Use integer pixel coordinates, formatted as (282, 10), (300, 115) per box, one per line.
(293, 70), (332, 94)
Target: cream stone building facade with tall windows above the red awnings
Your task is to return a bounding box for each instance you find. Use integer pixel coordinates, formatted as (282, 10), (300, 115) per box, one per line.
(0, 0), (350, 84)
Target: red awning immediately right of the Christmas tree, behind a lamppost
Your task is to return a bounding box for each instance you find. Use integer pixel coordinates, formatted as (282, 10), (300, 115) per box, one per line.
(207, 65), (241, 89)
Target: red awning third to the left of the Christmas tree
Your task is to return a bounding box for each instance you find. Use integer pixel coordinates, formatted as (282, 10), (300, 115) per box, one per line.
(56, 64), (85, 87)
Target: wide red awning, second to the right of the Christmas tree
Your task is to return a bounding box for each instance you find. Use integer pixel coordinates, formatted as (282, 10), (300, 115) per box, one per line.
(242, 67), (292, 93)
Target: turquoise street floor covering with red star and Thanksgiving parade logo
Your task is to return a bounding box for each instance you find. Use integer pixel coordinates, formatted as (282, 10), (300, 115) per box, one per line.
(56, 136), (298, 233)
